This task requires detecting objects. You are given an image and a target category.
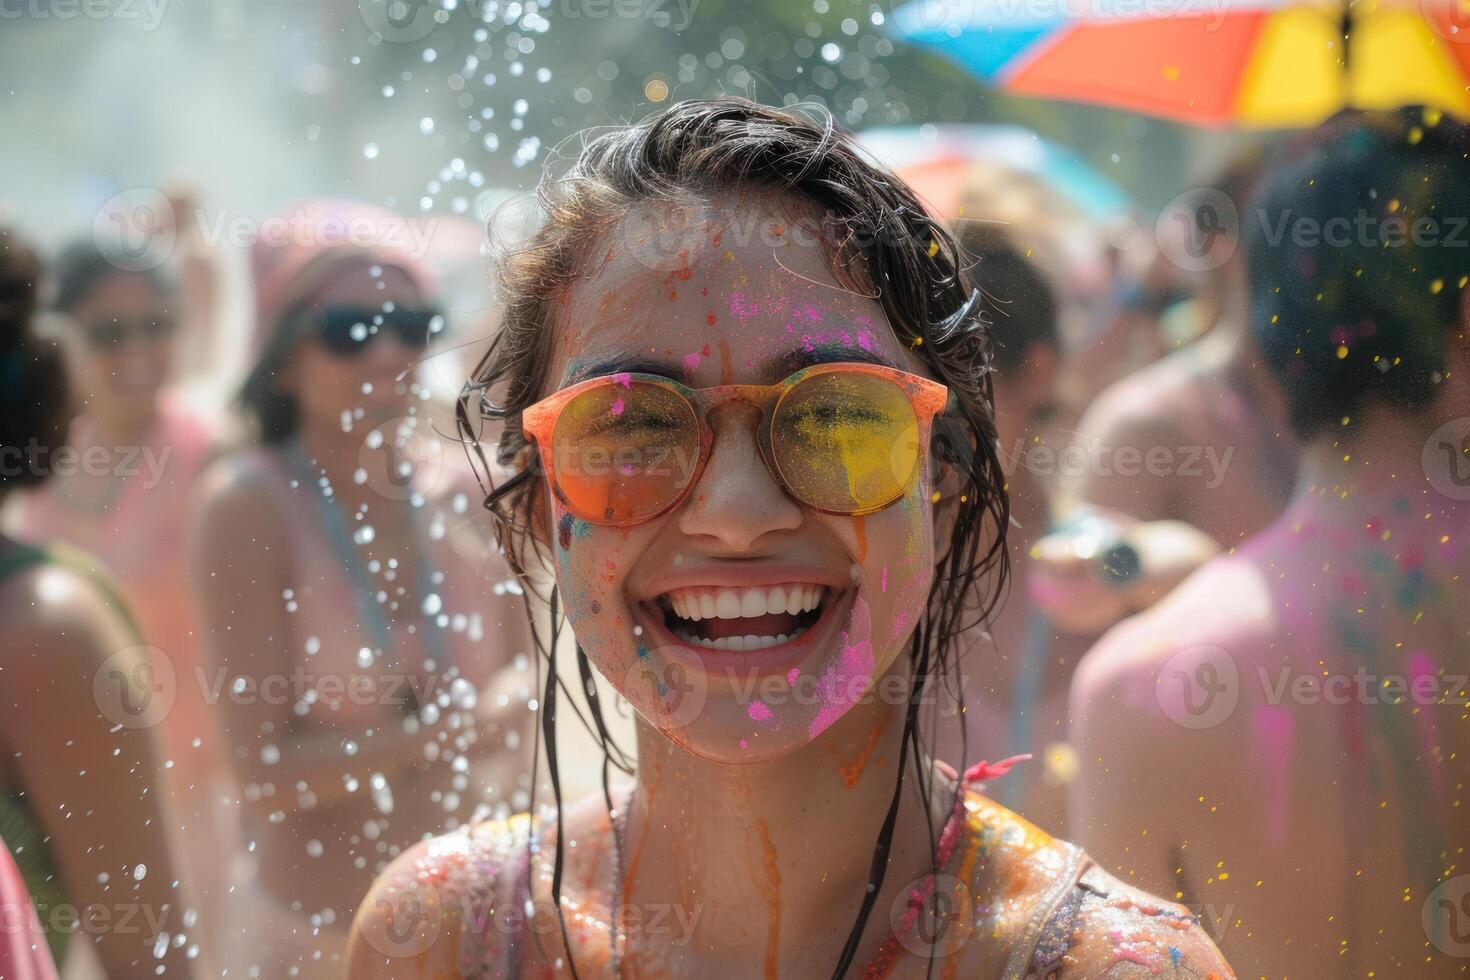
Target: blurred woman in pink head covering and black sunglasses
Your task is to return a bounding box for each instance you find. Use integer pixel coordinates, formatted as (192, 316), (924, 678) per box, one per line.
(190, 201), (531, 980)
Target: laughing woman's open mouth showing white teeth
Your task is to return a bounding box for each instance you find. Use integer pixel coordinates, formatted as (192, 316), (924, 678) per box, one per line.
(654, 582), (835, 651)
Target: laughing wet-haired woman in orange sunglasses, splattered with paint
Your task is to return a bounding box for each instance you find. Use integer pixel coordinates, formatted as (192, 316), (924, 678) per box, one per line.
(350, 100), (1230, 980)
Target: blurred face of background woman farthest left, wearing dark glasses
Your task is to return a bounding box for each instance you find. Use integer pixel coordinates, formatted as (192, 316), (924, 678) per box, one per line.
(66, 270), (178, 414)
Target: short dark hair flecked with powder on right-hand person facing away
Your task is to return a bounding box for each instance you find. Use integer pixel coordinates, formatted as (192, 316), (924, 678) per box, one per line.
(1245, 107), (1470, 438)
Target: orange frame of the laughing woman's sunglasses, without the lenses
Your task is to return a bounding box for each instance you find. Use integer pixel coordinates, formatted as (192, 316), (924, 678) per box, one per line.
(520, 361), (950, 527)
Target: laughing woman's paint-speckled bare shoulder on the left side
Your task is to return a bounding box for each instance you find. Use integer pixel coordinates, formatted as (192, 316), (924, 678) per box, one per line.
(347, 814), (531, 980)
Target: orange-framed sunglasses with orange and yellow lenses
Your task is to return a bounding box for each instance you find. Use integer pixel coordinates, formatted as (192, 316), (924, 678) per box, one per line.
(522, 361), (950, 526)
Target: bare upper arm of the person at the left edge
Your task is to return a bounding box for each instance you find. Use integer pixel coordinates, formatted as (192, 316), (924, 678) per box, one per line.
(0, 567), (198, 980)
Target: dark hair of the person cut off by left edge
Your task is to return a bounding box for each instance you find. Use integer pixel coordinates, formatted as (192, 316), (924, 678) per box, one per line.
(0, 228), (68, 498)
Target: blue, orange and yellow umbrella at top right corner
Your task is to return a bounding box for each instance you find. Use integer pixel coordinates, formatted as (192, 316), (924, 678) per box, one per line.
(891, 0), (1470, 128)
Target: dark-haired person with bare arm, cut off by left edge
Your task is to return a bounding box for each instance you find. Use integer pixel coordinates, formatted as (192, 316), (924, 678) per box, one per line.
(0, 229), (203, 980)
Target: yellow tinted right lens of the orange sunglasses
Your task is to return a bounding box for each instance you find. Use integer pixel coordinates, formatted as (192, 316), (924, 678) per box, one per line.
(770, 372), (919, 513)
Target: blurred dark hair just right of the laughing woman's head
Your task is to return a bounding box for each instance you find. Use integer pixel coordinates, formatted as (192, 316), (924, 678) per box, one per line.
(958, 222), (1061, 372)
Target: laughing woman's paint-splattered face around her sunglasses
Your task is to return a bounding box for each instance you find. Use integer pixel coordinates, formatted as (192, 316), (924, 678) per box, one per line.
(541, 189), (935, 763)
